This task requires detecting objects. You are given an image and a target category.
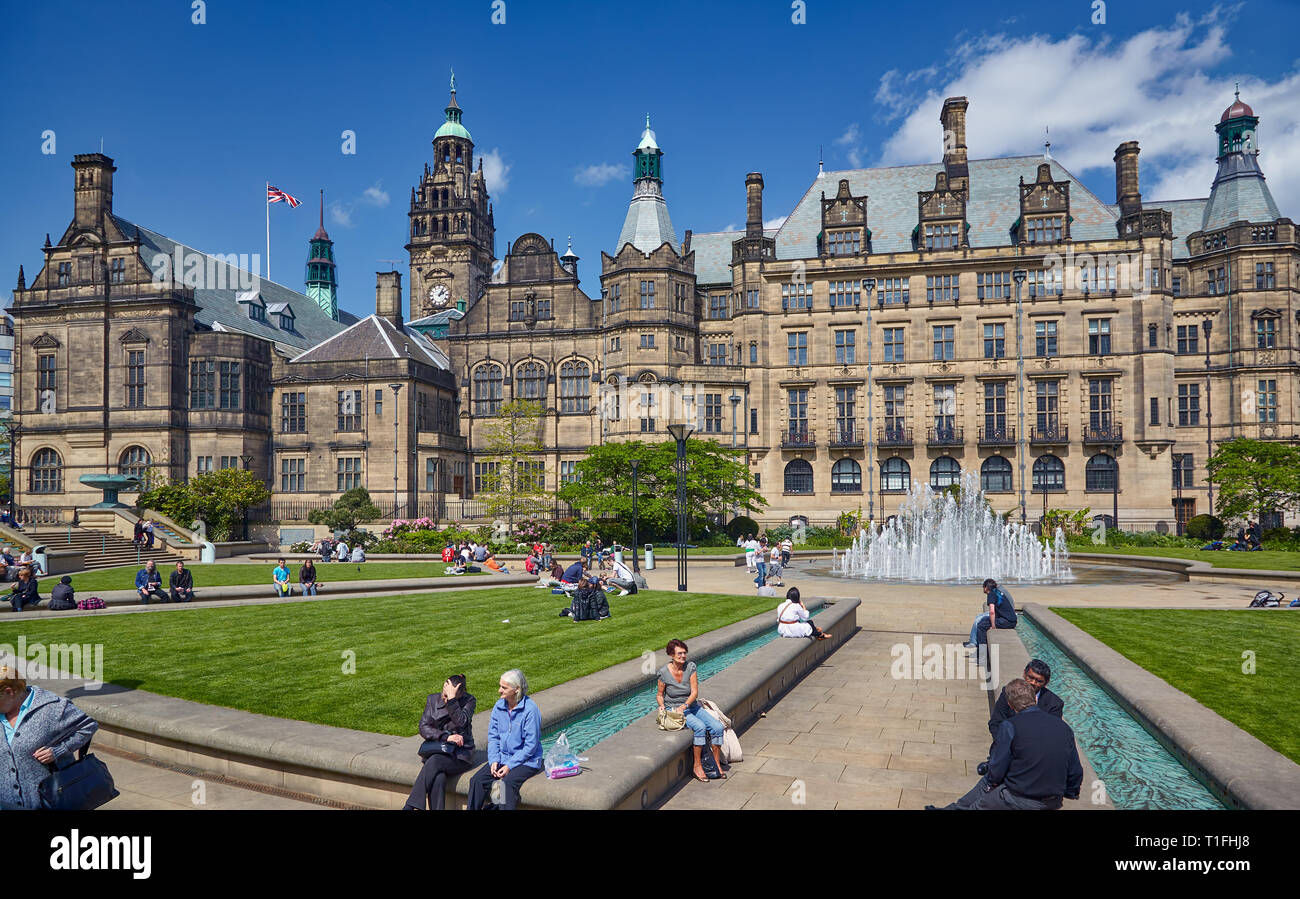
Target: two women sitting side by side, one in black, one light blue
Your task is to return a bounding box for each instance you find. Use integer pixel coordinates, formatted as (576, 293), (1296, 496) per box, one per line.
(403, 668), (542, 812)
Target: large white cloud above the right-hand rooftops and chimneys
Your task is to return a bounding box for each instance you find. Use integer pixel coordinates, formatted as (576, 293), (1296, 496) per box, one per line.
(868, 8), (1300, 217)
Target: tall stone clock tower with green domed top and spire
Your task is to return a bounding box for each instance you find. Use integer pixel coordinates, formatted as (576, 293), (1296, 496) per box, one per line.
(406, 73), (495, 320)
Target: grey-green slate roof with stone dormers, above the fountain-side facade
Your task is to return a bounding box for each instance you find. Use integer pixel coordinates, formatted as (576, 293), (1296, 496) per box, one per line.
(776, 156), (1117, 259)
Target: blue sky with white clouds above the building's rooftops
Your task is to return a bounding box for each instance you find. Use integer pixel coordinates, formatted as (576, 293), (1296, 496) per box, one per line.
(0, 0), (1300, 314)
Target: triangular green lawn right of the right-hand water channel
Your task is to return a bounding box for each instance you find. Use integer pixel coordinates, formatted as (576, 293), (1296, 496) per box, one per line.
(1052, 607), (1300, 763)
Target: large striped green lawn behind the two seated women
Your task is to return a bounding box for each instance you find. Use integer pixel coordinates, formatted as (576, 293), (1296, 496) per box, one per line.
(0, 587), (774, 744)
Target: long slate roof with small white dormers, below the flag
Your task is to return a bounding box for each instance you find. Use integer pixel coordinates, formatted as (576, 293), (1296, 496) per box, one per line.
(113, 216), (356, 352)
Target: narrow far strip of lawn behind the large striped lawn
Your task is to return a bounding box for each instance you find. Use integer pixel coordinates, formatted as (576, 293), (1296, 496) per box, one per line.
(40, 561), (480, 596)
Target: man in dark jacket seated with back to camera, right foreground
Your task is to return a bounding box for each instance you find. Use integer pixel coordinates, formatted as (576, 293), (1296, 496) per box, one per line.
(927, 678), (1083, 809)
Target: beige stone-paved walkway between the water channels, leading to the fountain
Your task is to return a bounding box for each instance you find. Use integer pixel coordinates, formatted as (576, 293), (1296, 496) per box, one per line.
(647, 563), (1255, 809)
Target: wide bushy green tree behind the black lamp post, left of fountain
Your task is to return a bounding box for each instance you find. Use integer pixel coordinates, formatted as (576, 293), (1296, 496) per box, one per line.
(559, 440), (767, 531)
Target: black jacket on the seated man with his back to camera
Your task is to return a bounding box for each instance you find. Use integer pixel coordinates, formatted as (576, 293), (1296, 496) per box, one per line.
(987, 705), (1083, 799)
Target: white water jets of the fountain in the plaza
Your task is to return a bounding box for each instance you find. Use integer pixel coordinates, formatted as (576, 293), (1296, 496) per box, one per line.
(832, 472), (1074, 583)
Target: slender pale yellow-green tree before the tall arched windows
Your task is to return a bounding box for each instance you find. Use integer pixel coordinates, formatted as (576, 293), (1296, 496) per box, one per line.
(482, 400), (547, 531)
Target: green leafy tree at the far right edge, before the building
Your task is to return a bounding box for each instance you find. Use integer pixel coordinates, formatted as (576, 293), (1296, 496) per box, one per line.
(1208, 439), (1300, 520)
